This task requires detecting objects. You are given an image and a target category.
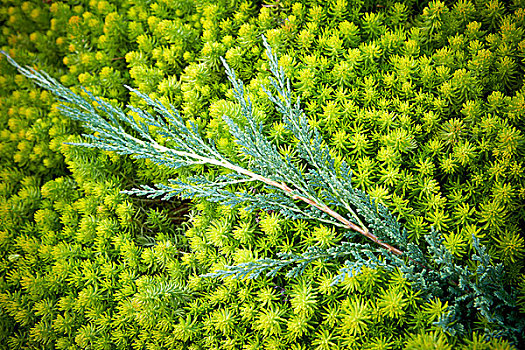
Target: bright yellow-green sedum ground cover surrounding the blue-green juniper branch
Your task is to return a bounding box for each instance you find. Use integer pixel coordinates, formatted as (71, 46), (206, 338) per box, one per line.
(0, 0), (525, 350)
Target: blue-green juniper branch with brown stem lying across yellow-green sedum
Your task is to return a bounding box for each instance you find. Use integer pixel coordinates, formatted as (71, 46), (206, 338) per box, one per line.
(4, 38), (525, 342)
